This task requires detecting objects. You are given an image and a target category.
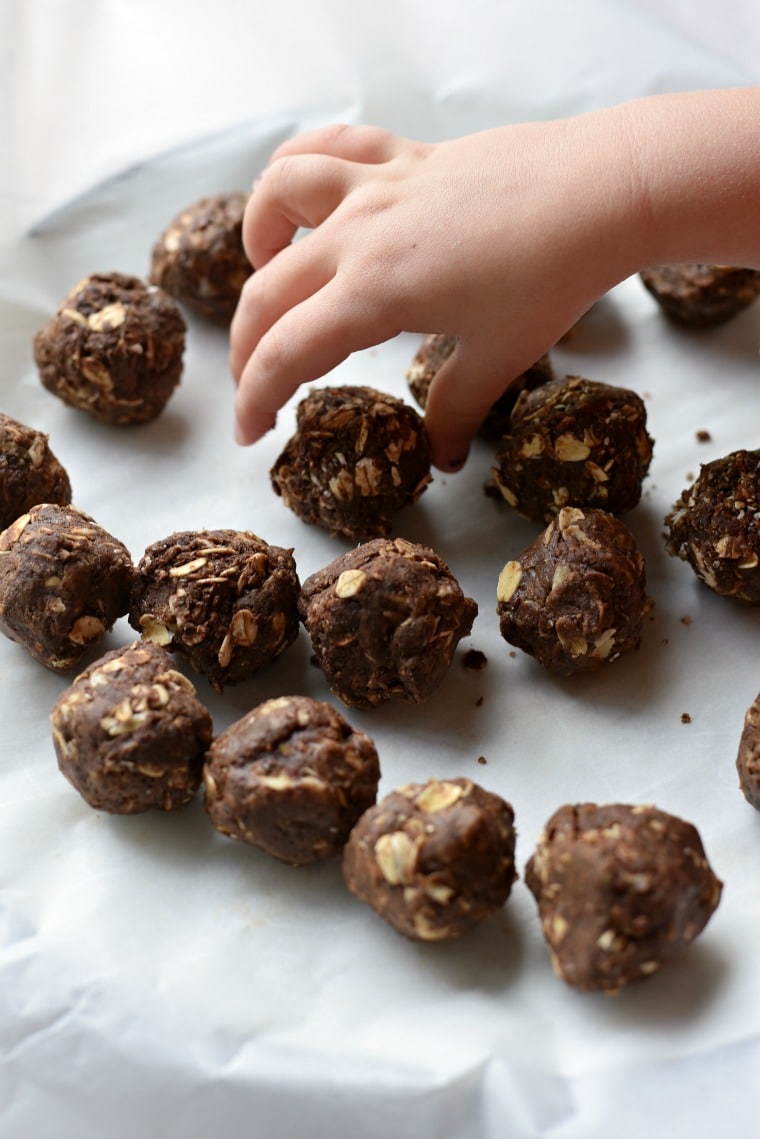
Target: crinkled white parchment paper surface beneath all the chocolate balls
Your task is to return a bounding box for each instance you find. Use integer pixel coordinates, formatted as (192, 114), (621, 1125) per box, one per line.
(0, 0), (760, 1139)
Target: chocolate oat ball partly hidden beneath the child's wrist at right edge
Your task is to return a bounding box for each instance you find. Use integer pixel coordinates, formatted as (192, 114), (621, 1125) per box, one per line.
(639, 263), (760, 328)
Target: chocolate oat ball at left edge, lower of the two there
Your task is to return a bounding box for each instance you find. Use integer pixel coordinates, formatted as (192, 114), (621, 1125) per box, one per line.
(0, 502), (134, 672)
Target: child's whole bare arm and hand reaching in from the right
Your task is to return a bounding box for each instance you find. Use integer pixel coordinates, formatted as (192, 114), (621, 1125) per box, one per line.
(230, 88), (760, 470)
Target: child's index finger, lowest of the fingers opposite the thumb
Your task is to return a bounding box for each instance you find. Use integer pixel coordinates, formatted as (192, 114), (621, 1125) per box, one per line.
(235, 274), (398, 443)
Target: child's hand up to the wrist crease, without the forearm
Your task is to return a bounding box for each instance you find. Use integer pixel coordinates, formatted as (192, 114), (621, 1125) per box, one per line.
(230, 116), (636, 469)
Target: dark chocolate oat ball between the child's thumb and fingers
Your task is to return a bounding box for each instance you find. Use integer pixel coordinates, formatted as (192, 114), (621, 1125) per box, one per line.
(270, 386), (431, 541)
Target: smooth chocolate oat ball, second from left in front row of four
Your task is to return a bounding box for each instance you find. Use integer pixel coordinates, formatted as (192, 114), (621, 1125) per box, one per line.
(203, 696), (379, 866)
